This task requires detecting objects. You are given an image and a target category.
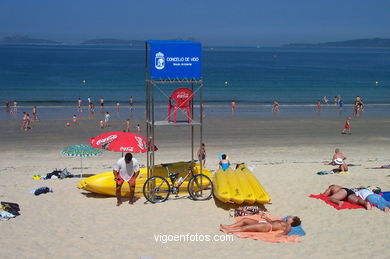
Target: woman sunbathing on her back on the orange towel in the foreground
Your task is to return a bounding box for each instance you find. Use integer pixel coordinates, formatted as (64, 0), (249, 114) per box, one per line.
(220, 215), (301, 235)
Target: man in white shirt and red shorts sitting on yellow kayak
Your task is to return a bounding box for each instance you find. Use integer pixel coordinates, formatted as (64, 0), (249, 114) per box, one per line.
(113, 153), (140, 206)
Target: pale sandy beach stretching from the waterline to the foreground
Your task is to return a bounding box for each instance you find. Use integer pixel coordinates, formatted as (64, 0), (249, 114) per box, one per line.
(0, 116), (390, 259)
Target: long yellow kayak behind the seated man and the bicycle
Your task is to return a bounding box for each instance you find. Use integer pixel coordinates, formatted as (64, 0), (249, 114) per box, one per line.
(77, 162), (211, 197)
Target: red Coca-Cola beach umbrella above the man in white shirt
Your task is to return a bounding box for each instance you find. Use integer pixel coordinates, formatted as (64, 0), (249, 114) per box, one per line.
(88, 131), (157, 153)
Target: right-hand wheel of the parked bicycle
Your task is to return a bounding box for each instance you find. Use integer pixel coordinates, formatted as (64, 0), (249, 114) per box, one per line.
(188, 174), (213, 201)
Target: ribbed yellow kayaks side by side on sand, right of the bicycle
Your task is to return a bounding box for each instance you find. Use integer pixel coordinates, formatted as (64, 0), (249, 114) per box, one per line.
(213, 165), (270, 204)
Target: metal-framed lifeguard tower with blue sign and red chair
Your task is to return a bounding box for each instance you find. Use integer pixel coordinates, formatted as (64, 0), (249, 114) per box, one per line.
(145, 40), (203, 178)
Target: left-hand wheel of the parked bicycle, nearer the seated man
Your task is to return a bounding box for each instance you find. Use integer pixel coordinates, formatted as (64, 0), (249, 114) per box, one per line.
(142, 176), (171, 203)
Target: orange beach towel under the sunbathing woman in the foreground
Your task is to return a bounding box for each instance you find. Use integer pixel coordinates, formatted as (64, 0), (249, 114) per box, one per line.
(230, 215), (304, 243)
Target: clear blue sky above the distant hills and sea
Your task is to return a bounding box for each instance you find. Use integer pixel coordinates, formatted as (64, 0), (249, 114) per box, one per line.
(0, 0), (390, 46)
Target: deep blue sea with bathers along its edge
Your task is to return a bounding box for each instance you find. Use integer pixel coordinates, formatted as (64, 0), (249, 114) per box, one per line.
(0, 46), (390, 118)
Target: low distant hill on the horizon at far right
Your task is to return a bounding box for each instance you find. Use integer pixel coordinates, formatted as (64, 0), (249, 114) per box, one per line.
(282, 38), (390, 48)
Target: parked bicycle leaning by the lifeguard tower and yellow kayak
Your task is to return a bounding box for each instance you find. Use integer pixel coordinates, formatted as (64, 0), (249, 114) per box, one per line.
(142, 162), (213, 203)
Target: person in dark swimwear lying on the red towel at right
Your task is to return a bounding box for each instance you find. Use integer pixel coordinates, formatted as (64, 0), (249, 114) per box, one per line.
(323, 184), (372, 210)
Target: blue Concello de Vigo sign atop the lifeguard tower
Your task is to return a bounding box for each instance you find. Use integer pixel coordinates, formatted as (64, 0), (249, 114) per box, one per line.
(147, 41), (202, 80)
